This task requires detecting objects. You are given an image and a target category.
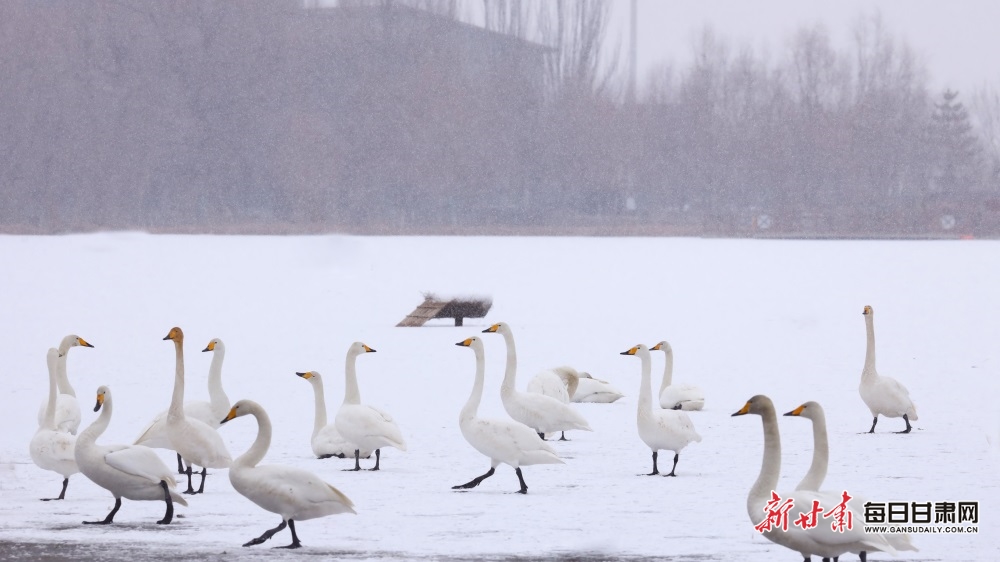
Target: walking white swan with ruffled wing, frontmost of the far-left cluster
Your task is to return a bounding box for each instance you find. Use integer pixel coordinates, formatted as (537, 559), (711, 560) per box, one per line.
(75, 386), (187, 525)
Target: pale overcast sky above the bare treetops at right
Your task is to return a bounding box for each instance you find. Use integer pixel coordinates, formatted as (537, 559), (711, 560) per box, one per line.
(613, 0), (1000, 93)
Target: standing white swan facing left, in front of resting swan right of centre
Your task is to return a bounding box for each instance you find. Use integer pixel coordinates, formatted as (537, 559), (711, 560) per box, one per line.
(621, 344), (701, 476)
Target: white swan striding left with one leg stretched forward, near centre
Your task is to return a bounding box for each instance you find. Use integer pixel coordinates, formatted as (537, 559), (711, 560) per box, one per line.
(452, 337), (563, 494)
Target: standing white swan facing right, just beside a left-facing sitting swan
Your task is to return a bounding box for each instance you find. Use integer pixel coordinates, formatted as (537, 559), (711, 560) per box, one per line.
(334, 342), (406, 470)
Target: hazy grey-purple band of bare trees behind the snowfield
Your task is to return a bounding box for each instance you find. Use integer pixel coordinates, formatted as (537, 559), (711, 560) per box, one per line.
(0, 0), (1000, 236)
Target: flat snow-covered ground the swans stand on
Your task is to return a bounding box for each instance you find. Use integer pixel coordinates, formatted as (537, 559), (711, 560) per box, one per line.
(0, 233), (1000, 561)
